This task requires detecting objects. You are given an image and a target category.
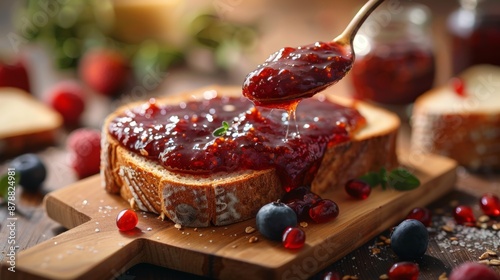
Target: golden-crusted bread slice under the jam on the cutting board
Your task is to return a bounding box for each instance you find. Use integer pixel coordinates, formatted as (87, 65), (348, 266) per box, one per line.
(101, 86), (400, 227)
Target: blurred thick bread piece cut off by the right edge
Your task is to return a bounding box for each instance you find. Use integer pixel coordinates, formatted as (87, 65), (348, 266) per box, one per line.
(411, 65), (500, 170)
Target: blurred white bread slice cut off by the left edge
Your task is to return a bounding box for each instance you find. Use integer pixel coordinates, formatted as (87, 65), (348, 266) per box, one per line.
(0, 87), (63, 158)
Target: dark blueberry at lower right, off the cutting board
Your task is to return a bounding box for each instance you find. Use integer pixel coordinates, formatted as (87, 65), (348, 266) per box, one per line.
(391, 219), (429, 260)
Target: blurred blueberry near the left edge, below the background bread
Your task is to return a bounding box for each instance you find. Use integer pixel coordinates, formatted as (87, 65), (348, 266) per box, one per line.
(10, 154), (47, 192)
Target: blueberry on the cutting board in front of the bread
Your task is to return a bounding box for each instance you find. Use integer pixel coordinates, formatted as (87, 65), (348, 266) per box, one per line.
(256, 201), (297, 241)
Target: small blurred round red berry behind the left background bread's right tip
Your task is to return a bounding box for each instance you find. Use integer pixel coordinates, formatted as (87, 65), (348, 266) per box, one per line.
(49, 81), (85, 125)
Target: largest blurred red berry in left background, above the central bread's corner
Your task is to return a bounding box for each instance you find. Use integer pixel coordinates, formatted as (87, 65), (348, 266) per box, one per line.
(78, 49), (131, 96)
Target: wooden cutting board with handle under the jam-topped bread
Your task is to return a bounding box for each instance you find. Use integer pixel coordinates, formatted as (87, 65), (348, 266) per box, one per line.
(2, 153), (456, 279)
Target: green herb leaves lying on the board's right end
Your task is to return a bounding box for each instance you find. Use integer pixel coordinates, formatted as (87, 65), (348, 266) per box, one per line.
(359, 167), (420, 191)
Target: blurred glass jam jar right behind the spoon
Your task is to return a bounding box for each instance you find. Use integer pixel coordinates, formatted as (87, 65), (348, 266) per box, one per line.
(350, 3), (435, 105)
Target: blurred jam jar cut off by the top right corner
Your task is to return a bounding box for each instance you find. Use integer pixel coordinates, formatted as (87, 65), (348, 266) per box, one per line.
(448, 0), (500, 75)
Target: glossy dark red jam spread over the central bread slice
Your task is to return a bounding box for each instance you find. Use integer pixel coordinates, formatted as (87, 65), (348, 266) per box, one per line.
(108, 92), (365, 190)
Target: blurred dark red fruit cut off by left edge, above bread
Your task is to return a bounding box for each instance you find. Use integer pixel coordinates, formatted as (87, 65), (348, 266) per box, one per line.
(0, 60), (30, 92)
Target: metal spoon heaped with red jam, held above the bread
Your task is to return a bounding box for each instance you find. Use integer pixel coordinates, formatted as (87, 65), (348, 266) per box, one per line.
(242, 0), (384, 111)
